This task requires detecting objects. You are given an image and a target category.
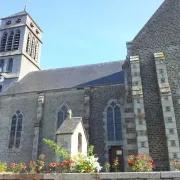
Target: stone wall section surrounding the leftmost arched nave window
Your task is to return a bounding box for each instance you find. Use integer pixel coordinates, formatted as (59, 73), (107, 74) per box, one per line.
(0, 94), (38, 163)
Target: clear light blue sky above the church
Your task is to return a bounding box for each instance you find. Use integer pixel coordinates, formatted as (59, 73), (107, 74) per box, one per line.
(0, 0), (163, 69)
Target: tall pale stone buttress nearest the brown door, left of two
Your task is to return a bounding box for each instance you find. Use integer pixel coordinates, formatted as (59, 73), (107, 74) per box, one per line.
(130, 56), (149, 155)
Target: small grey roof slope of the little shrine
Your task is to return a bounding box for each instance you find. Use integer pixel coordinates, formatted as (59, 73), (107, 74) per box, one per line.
(56, 117), (82, 134)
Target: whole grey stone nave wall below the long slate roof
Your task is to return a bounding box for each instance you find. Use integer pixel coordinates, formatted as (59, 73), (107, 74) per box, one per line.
(0, 85), (127, 165)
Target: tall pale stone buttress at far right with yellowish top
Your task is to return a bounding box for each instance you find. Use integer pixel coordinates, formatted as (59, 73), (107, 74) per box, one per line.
(154, 52), (180, 170)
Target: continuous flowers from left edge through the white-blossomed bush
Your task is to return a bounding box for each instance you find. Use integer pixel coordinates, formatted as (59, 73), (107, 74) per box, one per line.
(0, 139), (101, 174)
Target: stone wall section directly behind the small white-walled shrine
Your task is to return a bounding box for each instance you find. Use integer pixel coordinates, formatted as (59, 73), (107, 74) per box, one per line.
(39, 90), (84, 162)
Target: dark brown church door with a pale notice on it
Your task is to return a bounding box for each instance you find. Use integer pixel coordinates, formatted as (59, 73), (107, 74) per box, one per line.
(109, 146), (124, 172)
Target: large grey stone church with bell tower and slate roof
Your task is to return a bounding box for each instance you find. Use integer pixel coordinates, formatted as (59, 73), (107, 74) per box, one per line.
(0, 0), (180, 171)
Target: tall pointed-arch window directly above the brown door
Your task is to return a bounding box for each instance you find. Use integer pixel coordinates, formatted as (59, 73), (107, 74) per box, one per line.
(107, 101), (122, 141)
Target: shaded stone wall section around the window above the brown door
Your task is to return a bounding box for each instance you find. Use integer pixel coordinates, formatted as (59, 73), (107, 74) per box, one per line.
(89, 85), (125, 165)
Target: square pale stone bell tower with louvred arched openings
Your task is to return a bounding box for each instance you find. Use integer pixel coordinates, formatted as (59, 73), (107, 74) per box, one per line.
(0, 11), (42, 92)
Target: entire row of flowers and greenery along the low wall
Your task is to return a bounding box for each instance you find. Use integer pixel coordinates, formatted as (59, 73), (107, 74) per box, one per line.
(0, 139), (158, 174)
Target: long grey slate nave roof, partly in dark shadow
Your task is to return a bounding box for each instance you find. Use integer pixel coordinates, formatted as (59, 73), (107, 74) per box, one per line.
(4, 61), (124, 94)
